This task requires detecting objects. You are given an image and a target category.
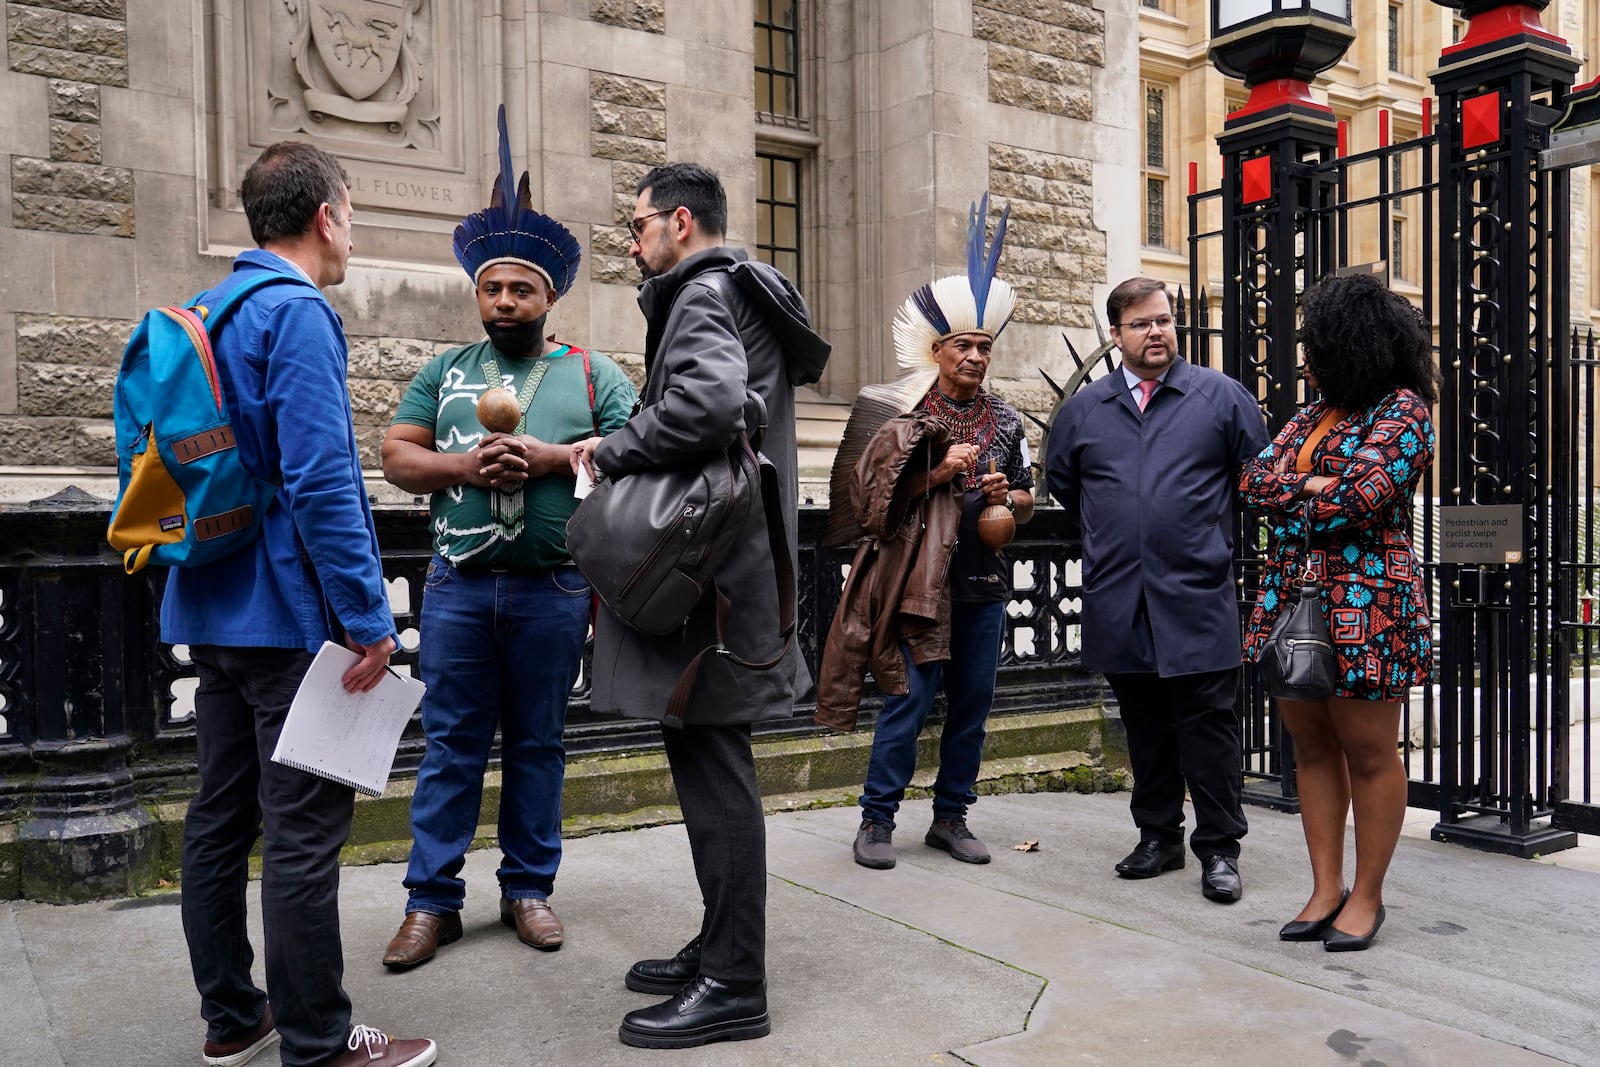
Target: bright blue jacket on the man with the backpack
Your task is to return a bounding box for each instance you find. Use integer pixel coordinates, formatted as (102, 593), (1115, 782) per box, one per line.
(162, 250), (395, 651)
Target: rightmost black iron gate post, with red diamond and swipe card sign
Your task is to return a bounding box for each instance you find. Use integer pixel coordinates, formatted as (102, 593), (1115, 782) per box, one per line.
(1432, 0), (1579, 857)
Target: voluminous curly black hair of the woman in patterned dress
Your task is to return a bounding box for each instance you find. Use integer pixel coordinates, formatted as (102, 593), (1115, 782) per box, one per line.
(1301, 274), (1438, 411)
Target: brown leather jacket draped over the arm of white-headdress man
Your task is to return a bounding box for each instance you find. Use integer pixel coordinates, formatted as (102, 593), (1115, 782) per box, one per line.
(814, 413), (962, 729)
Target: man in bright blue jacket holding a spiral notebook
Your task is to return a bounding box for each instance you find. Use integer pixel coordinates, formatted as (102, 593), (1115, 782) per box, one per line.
(162, 141), (437, 1067)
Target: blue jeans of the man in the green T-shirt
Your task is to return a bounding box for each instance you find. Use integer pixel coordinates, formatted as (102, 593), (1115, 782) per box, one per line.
(405, 555), (589, 913)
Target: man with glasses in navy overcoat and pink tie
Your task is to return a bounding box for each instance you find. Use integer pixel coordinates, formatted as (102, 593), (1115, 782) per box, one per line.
(1045, 278), (1267, 904)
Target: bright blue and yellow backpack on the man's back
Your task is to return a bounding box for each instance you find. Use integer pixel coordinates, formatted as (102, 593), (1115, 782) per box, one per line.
(106, 272), (309, 574)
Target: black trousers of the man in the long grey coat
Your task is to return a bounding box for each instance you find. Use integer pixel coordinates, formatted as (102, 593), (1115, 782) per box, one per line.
(661, 723), (766, 982)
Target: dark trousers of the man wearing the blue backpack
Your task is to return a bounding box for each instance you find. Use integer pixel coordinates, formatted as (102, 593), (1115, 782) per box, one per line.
(182, 645), (355, 1067)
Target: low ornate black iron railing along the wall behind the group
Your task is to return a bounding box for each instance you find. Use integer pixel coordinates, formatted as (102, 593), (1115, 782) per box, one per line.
(0, 490), (1101, 817)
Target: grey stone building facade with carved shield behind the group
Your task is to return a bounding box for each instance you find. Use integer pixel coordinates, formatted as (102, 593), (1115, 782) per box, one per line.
(0, 0), (1152, 501)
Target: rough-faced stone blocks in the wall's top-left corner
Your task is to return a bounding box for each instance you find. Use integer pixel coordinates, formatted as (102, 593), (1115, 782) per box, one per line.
(5, 0), (134, 237)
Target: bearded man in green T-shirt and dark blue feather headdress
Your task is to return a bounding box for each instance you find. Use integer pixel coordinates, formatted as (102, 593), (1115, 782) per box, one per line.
(382, 107), (635, 969)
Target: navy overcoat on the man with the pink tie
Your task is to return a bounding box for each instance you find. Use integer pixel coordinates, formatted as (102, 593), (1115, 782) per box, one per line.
(1045, 360), (1267, 678)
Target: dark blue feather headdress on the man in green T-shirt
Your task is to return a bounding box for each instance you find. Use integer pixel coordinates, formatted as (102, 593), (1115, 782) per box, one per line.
(454, 104), (582, 296)
